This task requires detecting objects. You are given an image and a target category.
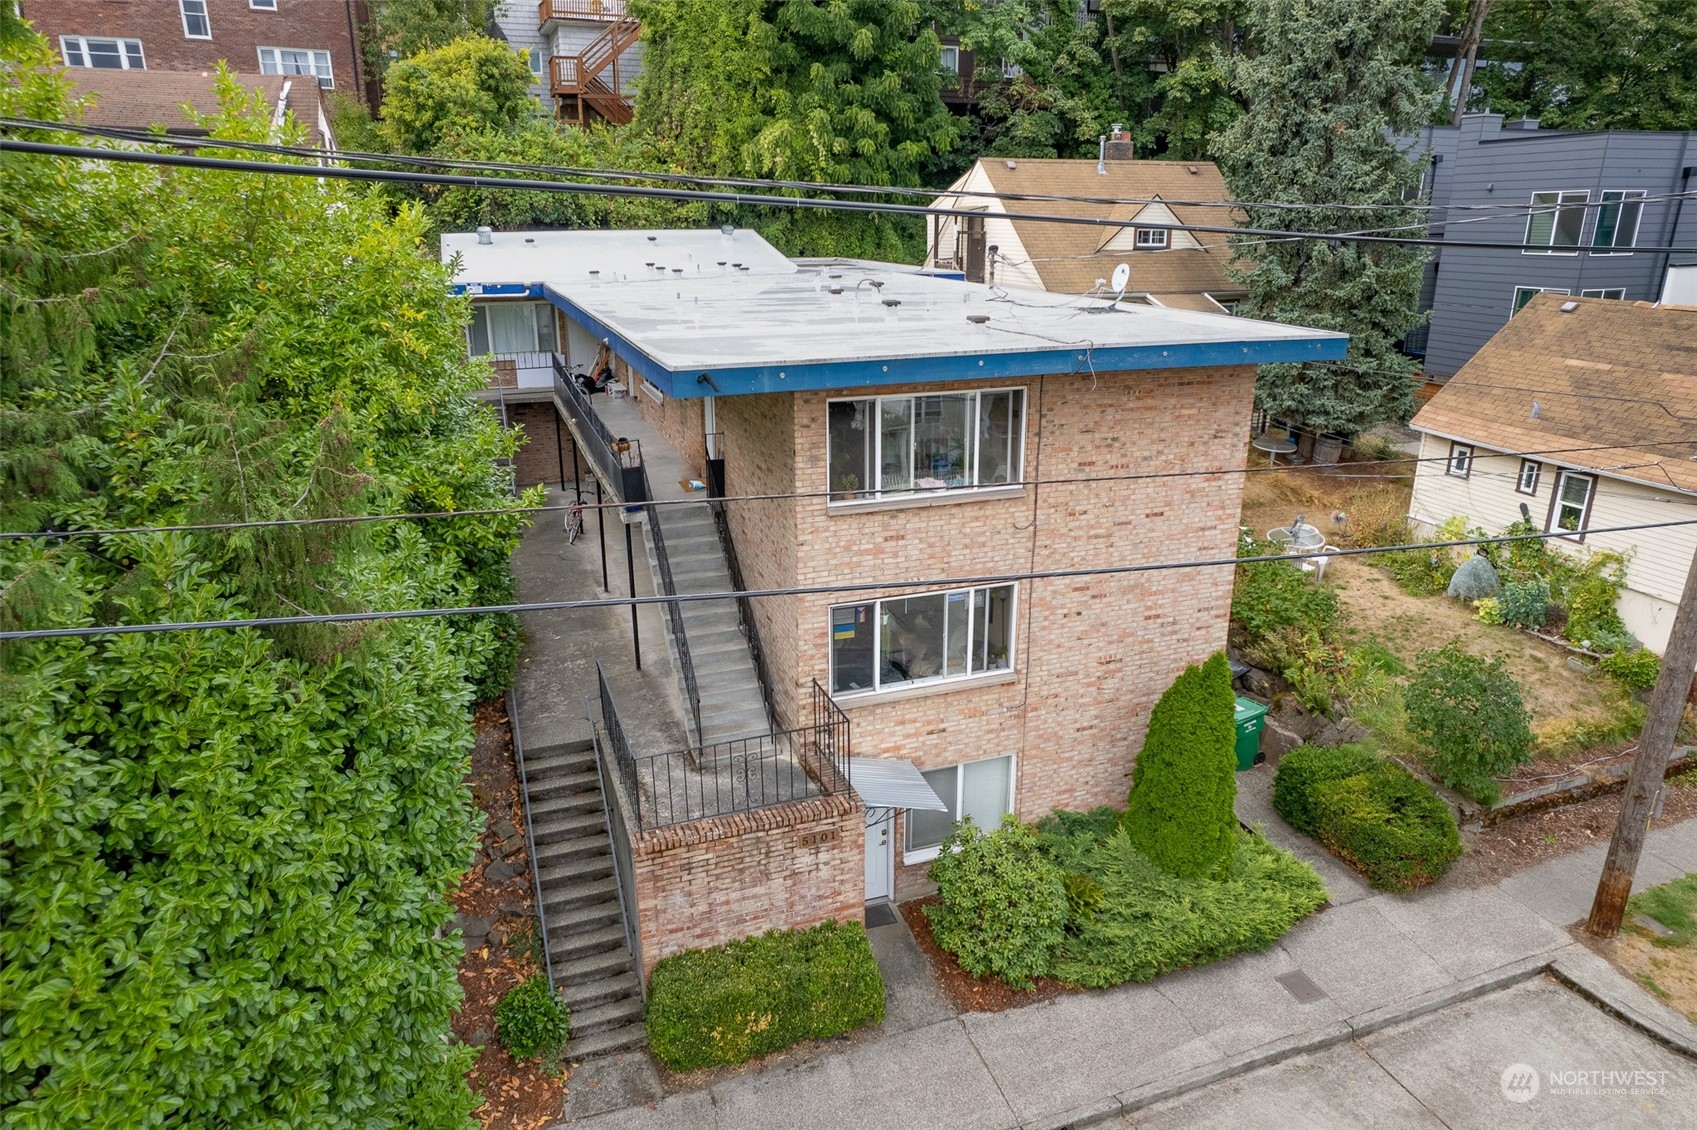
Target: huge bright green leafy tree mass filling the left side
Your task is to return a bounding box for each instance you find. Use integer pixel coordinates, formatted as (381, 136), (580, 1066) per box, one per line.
(0, 39), (523, 1127)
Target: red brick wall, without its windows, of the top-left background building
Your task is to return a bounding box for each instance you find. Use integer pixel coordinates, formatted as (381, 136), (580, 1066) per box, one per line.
(22, 0), (368, 107)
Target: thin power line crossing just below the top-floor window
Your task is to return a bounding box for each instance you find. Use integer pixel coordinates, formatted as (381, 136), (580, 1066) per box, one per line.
(13, 430), (1697, 541)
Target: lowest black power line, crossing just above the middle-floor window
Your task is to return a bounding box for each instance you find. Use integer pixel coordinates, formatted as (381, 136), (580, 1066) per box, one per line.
(0, 517), (1697, 643)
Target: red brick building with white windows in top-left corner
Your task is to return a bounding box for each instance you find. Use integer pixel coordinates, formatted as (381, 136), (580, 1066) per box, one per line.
(19, 0), (377, 107)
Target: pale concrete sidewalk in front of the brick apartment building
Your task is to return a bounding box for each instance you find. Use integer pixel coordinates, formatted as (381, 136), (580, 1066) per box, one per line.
(560, 767), (1697, 1130)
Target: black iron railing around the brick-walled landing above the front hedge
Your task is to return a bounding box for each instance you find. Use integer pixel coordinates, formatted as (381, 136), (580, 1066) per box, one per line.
(597, 668), (850, 830)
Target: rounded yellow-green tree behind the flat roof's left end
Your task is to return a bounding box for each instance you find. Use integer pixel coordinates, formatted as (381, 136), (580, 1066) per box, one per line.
(380, 36), (536, 153)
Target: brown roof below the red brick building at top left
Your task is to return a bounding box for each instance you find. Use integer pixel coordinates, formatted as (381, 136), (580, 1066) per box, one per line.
(64, 66), (324, 148)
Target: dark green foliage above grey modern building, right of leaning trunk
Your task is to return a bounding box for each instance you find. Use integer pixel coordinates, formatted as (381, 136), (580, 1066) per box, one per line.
(1468, 0), (1697, 129)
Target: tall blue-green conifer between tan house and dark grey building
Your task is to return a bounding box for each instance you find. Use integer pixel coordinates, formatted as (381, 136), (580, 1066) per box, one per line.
(1213, 0), (1441, 434)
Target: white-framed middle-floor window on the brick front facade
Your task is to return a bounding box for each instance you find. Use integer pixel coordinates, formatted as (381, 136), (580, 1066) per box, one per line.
(830, 585), (1013, 696)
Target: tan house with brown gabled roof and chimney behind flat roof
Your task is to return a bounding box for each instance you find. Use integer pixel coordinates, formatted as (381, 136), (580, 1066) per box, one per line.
(925, 134), (1246, 314)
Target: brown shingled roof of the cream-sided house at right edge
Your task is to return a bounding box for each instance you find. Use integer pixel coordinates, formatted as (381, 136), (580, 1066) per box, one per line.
(1412, 294), (1697, 492)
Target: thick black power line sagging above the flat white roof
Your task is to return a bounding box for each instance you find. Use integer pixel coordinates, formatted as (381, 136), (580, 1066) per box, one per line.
(16, 137), (1697, 255)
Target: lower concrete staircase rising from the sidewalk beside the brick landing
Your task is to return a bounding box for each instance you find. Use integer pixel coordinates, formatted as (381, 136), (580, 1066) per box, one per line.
(524, 741), (648, 1060)
